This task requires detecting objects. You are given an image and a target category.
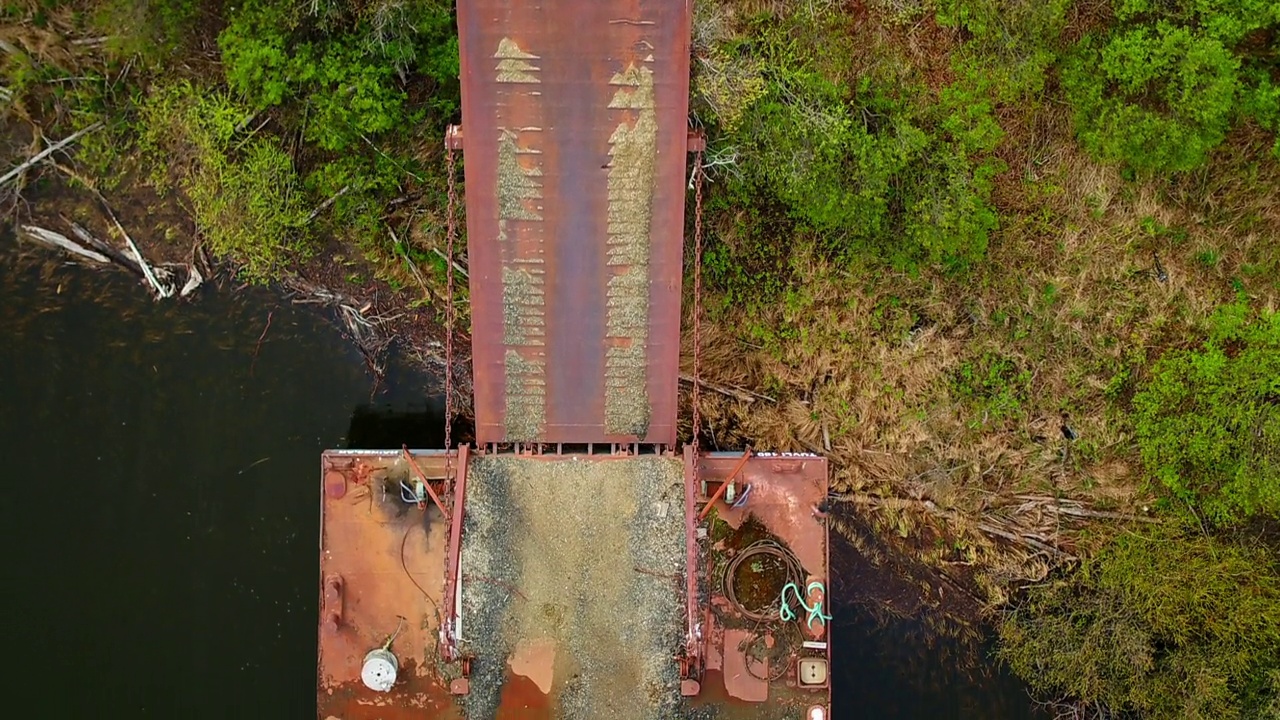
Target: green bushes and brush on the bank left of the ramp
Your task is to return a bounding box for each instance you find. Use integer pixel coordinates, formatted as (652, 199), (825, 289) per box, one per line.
(5, 0), (458, 288)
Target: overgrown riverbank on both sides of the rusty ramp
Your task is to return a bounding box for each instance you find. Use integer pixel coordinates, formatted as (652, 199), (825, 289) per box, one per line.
(10, 0), (1280, 717)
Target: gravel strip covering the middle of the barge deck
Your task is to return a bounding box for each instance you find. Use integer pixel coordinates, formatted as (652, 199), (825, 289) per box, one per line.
(462, 456), (685, 720)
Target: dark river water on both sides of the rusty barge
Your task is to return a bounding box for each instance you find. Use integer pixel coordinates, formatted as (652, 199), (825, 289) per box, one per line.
(0, 243), (1038, 720)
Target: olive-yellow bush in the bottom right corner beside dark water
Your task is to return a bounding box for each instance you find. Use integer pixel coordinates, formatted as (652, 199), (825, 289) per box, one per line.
(1000, 529), (1280, 720)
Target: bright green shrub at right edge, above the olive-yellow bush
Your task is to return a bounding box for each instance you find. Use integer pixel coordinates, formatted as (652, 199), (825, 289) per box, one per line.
(1134, 297), (1280, 524)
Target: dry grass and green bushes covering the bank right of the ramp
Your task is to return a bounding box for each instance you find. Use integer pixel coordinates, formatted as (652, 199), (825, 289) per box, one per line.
(694, 0), (1280, 719)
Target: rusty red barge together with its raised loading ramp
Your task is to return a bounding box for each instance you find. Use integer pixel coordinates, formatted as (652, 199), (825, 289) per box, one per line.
(316, 0), (831, 720)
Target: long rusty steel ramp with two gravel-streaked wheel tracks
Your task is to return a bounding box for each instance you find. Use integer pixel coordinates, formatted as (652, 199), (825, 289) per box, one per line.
(458, 0), (690, 445)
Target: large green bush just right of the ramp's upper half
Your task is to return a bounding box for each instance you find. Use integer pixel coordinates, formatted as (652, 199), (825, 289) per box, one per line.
(719, 18), (1002, 266)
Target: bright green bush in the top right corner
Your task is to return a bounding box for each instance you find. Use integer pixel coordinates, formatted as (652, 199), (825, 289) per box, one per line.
(1062, 0), (1280, 172)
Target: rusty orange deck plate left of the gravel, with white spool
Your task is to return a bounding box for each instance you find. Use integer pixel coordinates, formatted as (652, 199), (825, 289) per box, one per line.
(316, 451), (461, 720)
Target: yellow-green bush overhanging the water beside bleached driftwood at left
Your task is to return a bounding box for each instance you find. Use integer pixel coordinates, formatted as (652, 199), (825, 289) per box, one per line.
(141, 82), (308, 282)
